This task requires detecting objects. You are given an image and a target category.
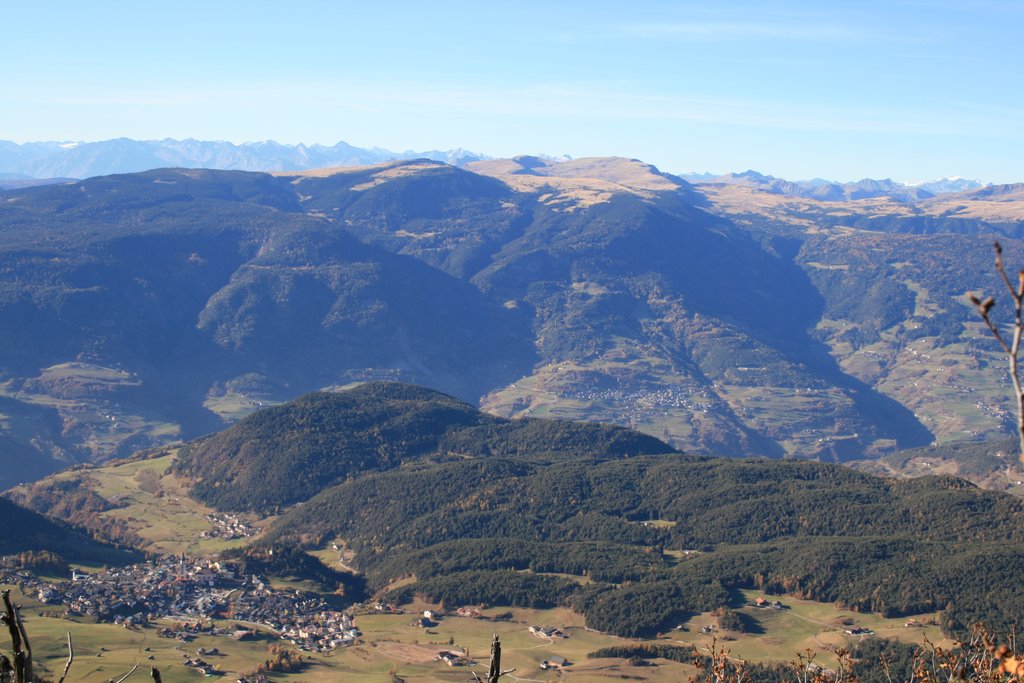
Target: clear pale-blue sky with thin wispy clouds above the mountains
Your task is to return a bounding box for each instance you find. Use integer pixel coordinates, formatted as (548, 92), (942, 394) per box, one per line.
(0, 0), (1024, 182)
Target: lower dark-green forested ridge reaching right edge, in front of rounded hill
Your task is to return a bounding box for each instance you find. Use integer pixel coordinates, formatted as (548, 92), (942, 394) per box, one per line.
(260, 440), (1024, 636)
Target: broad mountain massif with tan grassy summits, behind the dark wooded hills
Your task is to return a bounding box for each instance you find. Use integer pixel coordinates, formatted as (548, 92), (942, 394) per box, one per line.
(0, 158), (1024, 487)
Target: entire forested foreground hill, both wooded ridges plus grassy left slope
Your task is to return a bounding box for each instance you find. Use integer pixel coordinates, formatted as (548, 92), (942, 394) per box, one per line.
(9, 383), (1024, 636)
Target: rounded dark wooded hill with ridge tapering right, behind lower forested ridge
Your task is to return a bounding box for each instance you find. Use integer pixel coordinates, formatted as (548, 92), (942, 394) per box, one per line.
(176, 382), (673, 511)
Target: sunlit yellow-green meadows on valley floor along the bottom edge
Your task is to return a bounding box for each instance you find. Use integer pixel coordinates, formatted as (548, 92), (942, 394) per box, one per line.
(4, 585), (949, 683)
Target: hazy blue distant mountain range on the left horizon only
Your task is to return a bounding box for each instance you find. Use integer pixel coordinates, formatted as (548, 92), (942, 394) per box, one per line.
(0, 137), (484, 182)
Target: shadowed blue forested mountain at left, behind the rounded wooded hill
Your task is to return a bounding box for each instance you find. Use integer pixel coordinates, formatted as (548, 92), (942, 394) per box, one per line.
(0, 171), (534, 485)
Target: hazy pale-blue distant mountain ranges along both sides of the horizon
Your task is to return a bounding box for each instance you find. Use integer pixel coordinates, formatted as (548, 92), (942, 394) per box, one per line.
(0, 137), (984, 194)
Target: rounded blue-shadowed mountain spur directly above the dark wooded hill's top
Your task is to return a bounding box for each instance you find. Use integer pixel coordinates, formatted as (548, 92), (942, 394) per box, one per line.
(197, 222), (536, 399)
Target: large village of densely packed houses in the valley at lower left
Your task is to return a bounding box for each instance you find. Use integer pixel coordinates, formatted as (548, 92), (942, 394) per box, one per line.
(20, 555), (361, 652)
